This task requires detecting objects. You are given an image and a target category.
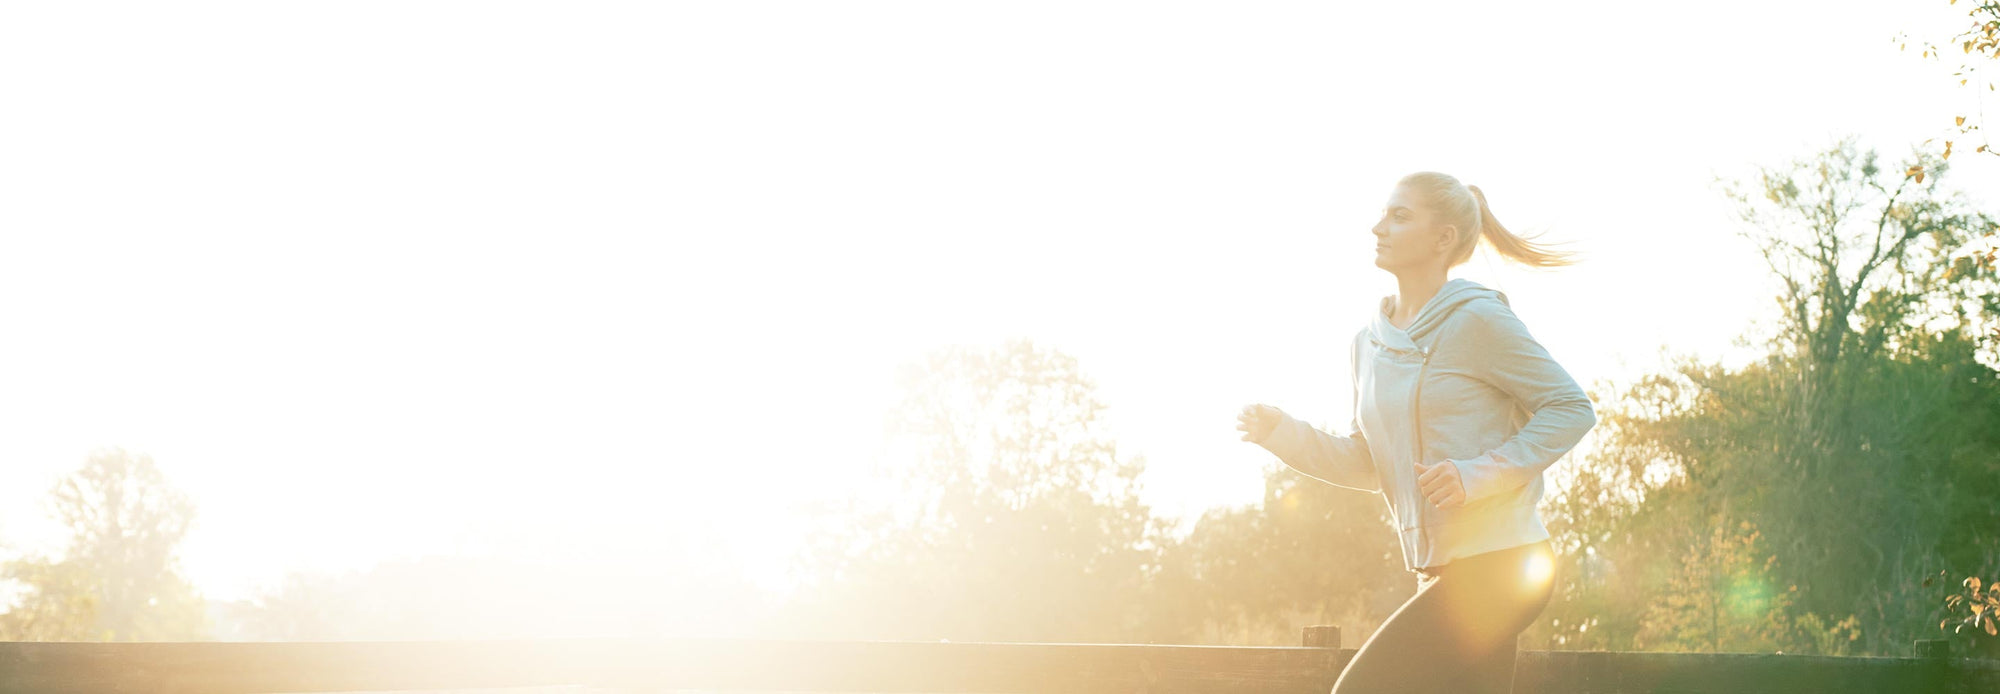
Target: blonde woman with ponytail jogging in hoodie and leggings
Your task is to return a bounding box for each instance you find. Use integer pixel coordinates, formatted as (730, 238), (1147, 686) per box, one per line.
(1236, 172), (1598, 694)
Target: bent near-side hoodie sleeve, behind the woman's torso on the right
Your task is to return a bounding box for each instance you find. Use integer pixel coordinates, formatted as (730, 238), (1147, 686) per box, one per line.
(1454, 302), (1598, 504)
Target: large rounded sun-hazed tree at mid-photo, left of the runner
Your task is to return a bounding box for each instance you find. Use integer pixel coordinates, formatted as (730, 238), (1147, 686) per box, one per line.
(776, 340), (1168, 642)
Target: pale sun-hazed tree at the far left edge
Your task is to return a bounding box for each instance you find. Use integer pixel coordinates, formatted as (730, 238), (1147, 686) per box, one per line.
(0, 450), (210, 640)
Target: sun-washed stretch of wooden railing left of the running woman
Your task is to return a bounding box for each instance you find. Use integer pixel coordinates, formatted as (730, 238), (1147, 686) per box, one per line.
(0, 638), (1354, 694)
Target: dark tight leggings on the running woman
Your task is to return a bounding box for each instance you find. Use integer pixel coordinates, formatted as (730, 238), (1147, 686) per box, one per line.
(1334, 540), (1556, 694)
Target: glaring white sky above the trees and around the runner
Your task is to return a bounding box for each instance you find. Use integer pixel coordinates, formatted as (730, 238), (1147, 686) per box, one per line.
(0, 0), (2000, 598)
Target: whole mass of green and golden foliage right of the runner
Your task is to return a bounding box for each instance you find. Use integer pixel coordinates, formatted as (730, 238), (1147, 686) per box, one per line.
(1538, 140), (2000, 654)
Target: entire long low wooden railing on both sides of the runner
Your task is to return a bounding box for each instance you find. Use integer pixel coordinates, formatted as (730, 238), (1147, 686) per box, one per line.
(0, 626), (2000, 694)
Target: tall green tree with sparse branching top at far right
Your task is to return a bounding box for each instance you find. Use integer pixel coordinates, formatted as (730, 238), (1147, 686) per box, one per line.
(1688, 138), (2000, 618)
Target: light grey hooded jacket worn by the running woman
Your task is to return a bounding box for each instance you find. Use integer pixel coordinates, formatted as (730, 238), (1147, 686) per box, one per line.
(1258, 278), (1598, 572)
